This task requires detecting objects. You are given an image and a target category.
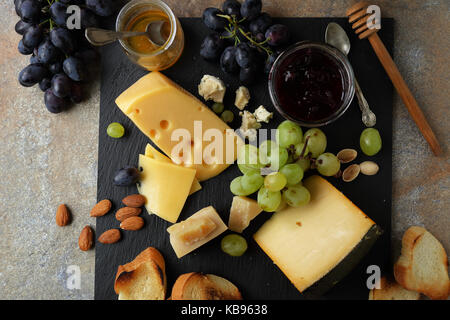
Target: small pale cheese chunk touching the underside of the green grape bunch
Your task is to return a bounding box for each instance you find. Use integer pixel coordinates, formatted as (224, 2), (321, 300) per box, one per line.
(228, 196), (262, 233)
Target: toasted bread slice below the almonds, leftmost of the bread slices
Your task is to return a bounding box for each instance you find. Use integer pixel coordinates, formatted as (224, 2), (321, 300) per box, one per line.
(114, 247), (166, 300)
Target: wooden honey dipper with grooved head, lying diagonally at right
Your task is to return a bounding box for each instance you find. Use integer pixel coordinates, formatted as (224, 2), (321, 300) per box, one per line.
(346, 1), (442, 156)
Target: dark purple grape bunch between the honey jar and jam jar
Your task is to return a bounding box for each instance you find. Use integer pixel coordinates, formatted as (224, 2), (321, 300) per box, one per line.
(200, 0), (290, 85)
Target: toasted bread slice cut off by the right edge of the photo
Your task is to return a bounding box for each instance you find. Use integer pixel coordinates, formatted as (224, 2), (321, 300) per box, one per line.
(394, 226), (450, 300)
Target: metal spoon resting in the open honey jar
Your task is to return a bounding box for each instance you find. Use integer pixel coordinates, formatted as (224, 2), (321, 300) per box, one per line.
(85, 21), (167, 47)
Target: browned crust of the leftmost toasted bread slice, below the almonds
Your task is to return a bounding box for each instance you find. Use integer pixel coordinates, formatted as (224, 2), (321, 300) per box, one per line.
(114, 247), (167, 294)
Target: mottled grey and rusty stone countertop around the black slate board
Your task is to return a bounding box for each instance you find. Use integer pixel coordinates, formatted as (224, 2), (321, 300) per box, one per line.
(0, 0), (450, 299)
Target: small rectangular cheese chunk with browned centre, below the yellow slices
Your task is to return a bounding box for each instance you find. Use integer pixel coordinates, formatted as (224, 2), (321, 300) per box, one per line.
(167, 206), (227, 258)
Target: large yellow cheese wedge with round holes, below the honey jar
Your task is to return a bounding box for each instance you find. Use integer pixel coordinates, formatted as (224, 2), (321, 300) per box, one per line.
(116, 72), (242, 181)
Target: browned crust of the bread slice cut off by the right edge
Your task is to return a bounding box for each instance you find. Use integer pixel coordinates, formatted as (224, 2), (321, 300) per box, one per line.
(394, 226), (450, 300)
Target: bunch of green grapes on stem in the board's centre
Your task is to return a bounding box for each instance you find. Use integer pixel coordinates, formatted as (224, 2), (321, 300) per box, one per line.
(230, 120), (352, 212)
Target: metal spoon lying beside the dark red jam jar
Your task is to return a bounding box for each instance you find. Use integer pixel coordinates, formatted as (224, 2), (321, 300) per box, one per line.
(325, 22), (377, 127)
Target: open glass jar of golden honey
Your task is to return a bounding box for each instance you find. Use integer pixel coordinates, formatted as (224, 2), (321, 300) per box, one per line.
(116, 0), (184, 71)
